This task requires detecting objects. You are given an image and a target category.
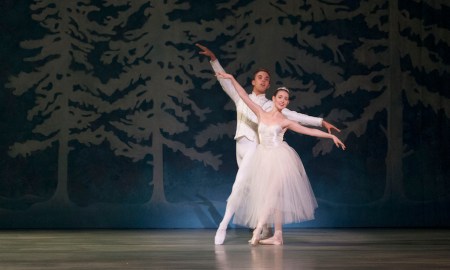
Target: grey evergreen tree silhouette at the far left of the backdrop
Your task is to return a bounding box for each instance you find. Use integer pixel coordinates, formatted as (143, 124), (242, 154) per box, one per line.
(6, 0), (110, 206)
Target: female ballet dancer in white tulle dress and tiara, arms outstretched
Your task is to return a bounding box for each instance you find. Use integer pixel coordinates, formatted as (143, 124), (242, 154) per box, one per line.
(217, 72), (345, 245)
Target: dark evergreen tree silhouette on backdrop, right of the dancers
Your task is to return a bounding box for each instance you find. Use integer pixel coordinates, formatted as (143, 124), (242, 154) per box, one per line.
(315, 0), (450, 203)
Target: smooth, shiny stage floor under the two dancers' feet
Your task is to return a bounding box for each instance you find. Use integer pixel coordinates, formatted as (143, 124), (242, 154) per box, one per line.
(0, 229), (450, 270)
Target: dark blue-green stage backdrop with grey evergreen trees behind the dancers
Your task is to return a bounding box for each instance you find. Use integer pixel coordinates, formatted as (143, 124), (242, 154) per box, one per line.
(0, 0), (450, 228)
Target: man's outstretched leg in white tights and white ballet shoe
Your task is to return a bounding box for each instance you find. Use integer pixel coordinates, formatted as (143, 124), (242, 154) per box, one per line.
(214, 137), (257, 245)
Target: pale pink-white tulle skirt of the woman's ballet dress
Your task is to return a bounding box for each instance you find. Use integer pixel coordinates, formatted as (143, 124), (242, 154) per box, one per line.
(228, 142), (317, 228)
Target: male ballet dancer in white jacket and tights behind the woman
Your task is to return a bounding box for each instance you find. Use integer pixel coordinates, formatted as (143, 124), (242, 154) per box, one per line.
(195, 44), (340, 245)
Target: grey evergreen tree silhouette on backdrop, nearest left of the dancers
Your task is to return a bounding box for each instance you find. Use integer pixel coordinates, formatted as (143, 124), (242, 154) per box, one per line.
(98, 1), (221, 204)
